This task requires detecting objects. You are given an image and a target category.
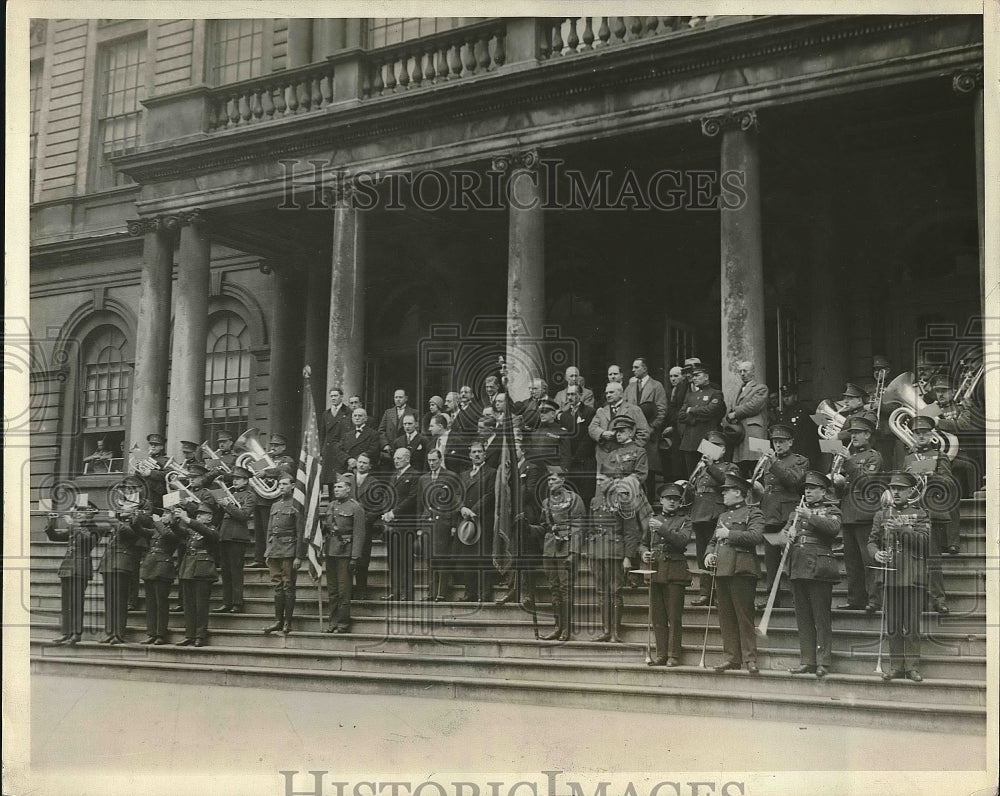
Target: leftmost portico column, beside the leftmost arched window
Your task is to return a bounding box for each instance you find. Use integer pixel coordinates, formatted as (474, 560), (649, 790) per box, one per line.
(127, 216), (177, 452)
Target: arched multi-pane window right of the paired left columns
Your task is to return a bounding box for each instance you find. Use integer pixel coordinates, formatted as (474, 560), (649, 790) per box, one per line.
(205, 310), (250, 440)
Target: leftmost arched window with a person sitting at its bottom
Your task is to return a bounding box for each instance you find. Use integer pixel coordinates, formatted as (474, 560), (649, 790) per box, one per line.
(76, 324), (132, 473)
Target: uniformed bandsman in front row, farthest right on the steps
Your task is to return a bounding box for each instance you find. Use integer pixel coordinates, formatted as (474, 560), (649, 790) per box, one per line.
(868, 473), (931, 683)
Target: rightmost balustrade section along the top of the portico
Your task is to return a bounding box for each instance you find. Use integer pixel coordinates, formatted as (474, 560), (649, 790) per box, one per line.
(538, 16), (713, 61)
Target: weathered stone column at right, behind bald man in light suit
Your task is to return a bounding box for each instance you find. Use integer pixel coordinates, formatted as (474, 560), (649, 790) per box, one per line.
(701, 110), (767, 400)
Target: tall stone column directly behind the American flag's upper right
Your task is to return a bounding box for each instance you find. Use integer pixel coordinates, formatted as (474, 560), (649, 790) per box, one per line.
(323, 185), (365, 398)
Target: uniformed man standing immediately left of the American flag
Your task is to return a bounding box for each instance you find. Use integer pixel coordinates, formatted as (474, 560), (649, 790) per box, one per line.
(264, 473), (306, 634)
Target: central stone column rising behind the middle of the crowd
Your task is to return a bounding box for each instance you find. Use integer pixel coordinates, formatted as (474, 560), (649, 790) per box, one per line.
(493, 151), (550, 400)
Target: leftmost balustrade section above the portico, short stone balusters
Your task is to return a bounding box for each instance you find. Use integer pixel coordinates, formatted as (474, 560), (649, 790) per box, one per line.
(208, 62), (334, 131)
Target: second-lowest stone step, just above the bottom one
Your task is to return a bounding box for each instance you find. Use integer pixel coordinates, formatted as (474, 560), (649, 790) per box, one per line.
(31, 634), (986, 707)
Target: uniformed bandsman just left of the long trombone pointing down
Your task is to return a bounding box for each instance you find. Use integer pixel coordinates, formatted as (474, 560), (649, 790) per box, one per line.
(705, 473), (764, 674)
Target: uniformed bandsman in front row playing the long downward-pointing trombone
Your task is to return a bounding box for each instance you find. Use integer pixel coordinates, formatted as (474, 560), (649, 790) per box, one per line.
(785, 470), (840, 677)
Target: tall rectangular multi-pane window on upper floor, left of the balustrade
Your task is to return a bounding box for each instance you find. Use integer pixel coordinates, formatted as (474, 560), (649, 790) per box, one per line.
(94, 36), (146, 190)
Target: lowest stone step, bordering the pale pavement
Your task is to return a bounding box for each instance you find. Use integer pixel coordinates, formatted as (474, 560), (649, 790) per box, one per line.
(31, 648), (986, 734)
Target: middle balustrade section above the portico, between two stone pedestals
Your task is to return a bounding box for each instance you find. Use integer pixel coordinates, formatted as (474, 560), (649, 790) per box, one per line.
(361, 20), (507, 99)
